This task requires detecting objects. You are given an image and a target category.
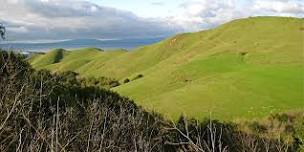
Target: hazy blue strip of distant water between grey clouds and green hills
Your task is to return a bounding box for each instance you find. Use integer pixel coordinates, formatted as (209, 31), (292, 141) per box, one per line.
(0, 38), (164, 52)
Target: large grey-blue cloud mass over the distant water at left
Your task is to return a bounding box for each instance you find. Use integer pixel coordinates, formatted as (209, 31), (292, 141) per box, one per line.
(0, 0), (177, 39)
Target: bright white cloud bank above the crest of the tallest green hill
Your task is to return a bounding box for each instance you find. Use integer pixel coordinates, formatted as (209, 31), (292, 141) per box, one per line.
(168, 0), (304, 31)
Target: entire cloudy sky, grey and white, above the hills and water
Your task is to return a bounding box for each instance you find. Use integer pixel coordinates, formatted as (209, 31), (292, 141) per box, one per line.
(0, 0), (304, 40)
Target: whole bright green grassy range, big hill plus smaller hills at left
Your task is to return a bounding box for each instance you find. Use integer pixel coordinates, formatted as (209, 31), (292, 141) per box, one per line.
(30, 17), (304, 119)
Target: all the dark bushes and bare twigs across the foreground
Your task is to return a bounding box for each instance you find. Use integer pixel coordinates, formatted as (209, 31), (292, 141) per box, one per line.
(0, 51), (304, 152)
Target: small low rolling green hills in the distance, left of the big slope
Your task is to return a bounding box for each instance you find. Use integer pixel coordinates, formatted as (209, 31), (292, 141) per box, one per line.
(29, 48), (126, 76)
